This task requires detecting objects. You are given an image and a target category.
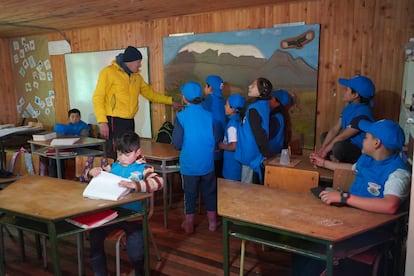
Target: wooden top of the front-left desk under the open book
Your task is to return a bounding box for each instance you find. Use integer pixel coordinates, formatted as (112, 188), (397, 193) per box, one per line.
(0, 175), (151, 220)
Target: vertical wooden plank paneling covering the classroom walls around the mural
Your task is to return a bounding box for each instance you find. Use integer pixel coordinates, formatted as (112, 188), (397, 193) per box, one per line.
(0, 0), (414, 142)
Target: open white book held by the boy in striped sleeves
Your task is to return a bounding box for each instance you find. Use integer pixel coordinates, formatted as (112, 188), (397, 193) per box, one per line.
(83, 171), (131, 201)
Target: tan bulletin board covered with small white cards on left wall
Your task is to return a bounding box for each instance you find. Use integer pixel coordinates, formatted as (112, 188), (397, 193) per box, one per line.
(10, 36), (55, 125)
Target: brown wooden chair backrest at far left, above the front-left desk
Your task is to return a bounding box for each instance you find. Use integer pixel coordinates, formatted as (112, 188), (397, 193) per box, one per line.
(6, 149), (40, 175)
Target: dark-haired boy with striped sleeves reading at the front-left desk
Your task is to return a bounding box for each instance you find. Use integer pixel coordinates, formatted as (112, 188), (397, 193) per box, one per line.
(87, 131), (163, 275)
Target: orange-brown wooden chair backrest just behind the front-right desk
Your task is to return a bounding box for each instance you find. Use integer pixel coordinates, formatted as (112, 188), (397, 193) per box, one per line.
(264, 165), (319, 193)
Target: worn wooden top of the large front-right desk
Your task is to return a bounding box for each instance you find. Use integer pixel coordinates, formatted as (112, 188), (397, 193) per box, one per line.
(217, 178), (404, 242)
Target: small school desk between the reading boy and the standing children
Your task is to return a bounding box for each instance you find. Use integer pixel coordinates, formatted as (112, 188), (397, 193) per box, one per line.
(141, 139), (180, 228)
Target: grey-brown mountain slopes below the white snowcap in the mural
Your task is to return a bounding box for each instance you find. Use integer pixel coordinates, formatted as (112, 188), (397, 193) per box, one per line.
(164, 43), (317, 94)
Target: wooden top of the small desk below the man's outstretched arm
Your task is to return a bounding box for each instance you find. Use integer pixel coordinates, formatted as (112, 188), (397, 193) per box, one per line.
(141, 139), (180, 161)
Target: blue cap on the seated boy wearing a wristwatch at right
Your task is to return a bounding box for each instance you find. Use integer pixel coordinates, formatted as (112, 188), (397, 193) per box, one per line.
(358, 120), (405, 150)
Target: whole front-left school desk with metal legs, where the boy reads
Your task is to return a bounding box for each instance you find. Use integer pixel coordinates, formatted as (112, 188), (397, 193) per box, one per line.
(0, 175), (151, 275)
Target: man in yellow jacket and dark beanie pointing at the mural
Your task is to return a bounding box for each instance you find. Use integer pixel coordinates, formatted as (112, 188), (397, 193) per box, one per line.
(92, 46), (180, 158)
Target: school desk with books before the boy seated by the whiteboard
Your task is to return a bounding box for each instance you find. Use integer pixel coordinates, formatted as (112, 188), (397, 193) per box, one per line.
(27, 136), (106, 178)
